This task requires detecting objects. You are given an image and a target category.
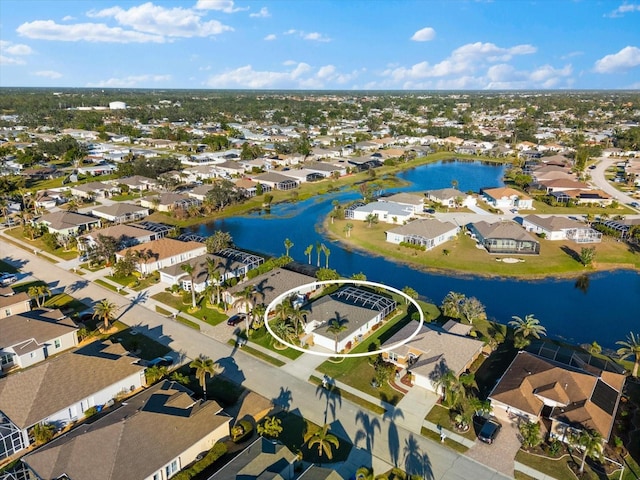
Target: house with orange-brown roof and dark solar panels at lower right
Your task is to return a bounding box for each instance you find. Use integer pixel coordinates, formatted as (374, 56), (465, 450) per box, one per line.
(488, 351), (625, 441)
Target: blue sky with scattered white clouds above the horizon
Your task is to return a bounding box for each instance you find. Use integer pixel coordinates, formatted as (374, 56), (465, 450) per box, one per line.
(0, 0), (640, 90)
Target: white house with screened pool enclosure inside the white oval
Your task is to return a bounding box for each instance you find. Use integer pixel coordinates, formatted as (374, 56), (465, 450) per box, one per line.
(303, 286), (396, 353)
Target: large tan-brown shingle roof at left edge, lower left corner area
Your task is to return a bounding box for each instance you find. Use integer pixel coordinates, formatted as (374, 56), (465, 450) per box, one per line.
(0, 342), (144, 428)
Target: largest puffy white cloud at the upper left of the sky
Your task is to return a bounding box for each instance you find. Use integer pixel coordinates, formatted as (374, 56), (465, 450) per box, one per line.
(88, 2), (233, 38)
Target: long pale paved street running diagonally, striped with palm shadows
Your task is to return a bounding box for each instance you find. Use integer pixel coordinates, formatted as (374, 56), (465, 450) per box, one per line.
(0, 238), (510, 480)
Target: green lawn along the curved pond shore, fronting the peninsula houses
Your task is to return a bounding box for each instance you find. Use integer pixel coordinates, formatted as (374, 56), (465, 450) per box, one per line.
(325, 220), (640, 278)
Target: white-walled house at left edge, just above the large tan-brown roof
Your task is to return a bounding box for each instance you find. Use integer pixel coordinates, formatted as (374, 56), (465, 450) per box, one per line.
(0, 310), (78, 370)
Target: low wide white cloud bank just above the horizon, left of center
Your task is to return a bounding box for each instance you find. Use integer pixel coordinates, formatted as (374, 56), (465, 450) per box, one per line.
(206, 61), (360, 89)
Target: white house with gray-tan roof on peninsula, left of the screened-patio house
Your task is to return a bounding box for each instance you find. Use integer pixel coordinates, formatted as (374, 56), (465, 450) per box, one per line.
(385, 218), (460, 250)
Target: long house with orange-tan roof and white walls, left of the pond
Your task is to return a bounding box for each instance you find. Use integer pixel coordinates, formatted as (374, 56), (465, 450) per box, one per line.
(116, 238), (207, 275)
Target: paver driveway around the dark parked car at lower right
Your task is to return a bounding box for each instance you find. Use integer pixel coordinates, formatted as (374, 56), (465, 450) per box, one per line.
(466, 420), (521, 477)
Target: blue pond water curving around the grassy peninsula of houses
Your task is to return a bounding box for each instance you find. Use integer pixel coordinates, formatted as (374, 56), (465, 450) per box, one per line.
(191, 161), (640, 349)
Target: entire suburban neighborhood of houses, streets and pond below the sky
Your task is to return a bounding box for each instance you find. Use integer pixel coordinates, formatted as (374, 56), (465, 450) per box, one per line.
(0, 89), (640, 480)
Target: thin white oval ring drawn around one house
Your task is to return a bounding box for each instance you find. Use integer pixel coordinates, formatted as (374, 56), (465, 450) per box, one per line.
(264, 279), (424, 358)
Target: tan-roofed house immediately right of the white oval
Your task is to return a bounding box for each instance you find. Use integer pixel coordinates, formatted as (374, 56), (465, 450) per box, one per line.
(382, 322), (484, 392)
